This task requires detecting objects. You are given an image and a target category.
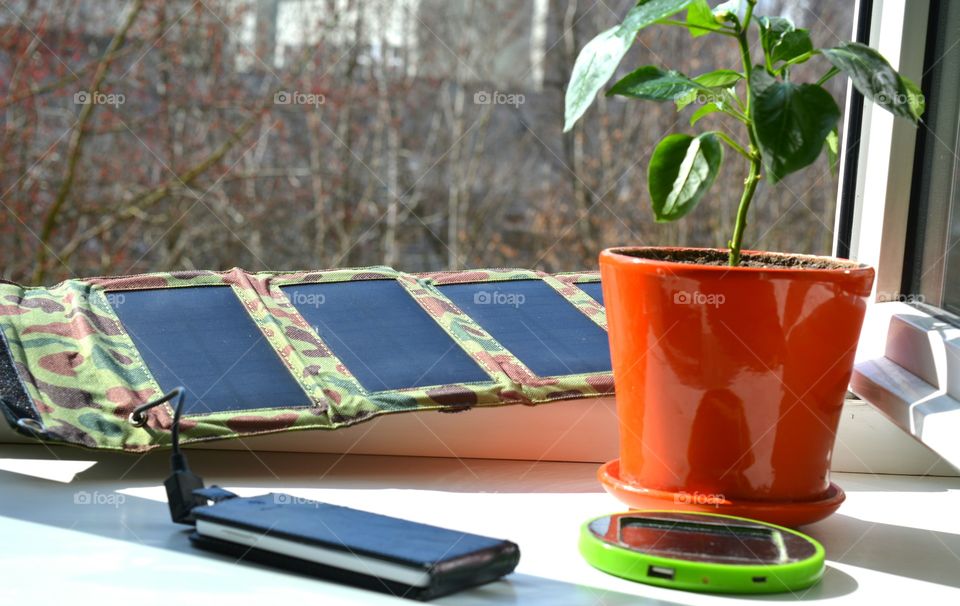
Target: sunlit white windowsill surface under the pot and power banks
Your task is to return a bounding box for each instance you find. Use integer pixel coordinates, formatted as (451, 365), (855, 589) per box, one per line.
(0, 445), (960, 606)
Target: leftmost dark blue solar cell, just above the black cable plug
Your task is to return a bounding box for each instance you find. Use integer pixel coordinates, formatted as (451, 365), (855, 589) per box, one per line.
(109, 286), (310, 413)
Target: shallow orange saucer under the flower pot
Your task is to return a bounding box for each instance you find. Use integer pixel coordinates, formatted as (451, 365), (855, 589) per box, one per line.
(597, 459), (847, 528)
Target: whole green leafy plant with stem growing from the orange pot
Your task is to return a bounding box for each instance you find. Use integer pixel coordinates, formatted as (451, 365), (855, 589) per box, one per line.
(564, 0), (924, 266)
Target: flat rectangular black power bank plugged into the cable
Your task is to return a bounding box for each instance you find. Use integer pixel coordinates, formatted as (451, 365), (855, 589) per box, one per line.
(190, 493), (520, 600)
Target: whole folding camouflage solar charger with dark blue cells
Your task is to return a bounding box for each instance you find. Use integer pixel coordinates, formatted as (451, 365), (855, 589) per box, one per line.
(0, 267), (613, 451)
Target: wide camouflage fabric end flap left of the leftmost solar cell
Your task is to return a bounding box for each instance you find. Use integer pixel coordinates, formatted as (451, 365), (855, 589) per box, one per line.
(0, 280), (164, 450)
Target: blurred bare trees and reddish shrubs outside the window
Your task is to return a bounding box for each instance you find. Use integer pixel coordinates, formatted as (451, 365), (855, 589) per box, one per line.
(0, 0), (854, 284)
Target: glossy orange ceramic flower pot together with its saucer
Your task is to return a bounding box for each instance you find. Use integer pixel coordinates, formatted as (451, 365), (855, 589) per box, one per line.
(600, 248), (874, 526)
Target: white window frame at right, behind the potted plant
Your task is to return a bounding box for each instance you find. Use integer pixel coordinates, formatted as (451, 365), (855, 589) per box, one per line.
(834, 0), (960, 474)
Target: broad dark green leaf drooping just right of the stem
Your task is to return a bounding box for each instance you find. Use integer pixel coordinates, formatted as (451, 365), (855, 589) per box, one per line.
(750, 66), (840, 183)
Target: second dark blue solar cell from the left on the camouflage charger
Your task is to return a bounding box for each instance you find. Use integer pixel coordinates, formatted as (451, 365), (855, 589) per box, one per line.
(283, 280), (492, 392)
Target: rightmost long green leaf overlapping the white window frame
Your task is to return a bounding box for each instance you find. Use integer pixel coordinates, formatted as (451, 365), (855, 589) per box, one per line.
(822, 42), (923, 122)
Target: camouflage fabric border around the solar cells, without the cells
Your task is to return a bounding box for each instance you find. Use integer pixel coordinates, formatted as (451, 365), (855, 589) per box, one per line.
(0, 267), (613, 452)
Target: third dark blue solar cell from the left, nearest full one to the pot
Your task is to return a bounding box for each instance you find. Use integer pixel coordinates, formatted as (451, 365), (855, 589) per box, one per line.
(439, 280), (610, 376)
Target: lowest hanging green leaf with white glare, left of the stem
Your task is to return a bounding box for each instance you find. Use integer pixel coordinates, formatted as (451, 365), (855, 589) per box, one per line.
(647, 133), (723, 223)
